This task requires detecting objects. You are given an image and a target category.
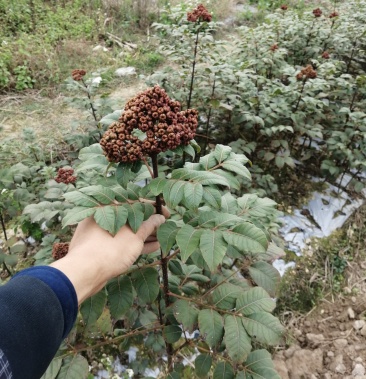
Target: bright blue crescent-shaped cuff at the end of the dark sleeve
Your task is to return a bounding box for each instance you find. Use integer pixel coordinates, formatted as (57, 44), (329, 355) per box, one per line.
(12, 266), (78, 338)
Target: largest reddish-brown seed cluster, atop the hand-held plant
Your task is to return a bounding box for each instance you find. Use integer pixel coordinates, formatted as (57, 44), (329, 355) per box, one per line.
(100, 86), (198, 162)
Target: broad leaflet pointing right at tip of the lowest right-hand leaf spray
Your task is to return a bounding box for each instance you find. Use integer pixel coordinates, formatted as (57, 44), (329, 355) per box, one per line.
(242, 312), (284, 345)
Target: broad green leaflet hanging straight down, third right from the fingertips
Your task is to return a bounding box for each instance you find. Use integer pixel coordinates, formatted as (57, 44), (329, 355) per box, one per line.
(200, 230), (227, 271)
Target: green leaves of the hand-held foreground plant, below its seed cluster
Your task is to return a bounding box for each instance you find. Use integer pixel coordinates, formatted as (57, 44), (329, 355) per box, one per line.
(25, 137), (283, 378)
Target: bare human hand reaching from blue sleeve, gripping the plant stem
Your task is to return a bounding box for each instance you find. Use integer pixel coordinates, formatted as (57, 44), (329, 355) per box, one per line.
(51, 209), (169, 304)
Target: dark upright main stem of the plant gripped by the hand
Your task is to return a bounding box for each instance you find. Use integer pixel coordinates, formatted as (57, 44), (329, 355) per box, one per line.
(150, 154), (174, 372)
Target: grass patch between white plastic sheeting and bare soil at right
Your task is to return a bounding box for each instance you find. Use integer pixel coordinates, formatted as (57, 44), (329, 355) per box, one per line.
(276, 205), (366, 315)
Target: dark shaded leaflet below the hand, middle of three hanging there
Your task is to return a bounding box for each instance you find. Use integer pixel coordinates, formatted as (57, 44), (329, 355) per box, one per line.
(107, 276), (133, 320)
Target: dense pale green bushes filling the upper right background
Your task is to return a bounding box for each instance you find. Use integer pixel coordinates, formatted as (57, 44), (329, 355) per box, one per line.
(148, 1), (366, 194)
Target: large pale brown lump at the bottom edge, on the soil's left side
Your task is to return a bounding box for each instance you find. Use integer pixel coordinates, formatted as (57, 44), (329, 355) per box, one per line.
(286, 349), (323, 379)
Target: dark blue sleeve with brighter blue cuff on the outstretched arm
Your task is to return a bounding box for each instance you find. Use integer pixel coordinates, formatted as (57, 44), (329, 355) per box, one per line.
(0, 266), (78, 379)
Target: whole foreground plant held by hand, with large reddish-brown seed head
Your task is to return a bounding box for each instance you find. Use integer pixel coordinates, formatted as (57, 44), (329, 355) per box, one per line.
(26, 86), (284, 379)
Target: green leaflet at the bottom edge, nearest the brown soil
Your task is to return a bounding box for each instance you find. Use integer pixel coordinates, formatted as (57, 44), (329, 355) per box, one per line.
(245, 349), (281, 379)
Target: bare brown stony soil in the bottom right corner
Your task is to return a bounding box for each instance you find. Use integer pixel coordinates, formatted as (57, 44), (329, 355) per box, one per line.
(274, 261), (366, 379)
